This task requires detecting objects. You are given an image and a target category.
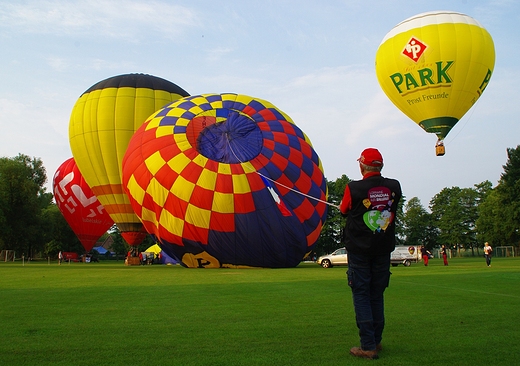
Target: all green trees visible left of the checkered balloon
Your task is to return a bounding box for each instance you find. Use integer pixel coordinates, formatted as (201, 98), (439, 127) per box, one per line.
(0, 154), (153, 259)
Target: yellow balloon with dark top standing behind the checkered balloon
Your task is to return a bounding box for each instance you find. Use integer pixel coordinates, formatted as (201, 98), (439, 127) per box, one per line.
(69, 74), (188, 245)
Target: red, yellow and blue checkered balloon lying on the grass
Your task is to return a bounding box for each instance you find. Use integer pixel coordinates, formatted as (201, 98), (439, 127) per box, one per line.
(123, 94), (327, 268)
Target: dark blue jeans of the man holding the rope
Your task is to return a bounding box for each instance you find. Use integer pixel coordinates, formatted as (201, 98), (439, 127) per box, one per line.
(347, 253), (391, 351)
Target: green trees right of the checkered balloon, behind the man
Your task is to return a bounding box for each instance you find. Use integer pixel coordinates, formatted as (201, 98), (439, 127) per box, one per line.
(315, 145), (520, 255)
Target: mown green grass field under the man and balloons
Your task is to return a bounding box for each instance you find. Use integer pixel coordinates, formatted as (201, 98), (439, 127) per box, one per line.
(0, 258), (520, 366)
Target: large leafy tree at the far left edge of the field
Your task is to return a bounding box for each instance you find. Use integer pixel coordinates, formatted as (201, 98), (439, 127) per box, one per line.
(0, 154), (52, 256)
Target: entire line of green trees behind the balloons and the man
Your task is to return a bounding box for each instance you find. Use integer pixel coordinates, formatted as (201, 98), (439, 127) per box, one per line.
(0, 145), (520, 258)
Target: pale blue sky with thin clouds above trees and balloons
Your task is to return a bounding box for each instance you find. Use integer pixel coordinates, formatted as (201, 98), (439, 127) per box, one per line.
(0, 0), (520, 208)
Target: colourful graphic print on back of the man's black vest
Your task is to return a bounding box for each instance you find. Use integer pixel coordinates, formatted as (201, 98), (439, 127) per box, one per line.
(363, 187), (395, 232)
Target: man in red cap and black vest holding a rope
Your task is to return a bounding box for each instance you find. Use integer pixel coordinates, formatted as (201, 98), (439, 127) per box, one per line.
(339, 148), (402, 359)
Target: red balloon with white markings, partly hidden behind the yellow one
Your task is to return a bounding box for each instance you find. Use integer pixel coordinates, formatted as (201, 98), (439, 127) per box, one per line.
(52, 158), (114, 252)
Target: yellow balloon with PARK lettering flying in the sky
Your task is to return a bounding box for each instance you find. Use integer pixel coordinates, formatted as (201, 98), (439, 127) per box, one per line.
(376, 11), (495, 155)
